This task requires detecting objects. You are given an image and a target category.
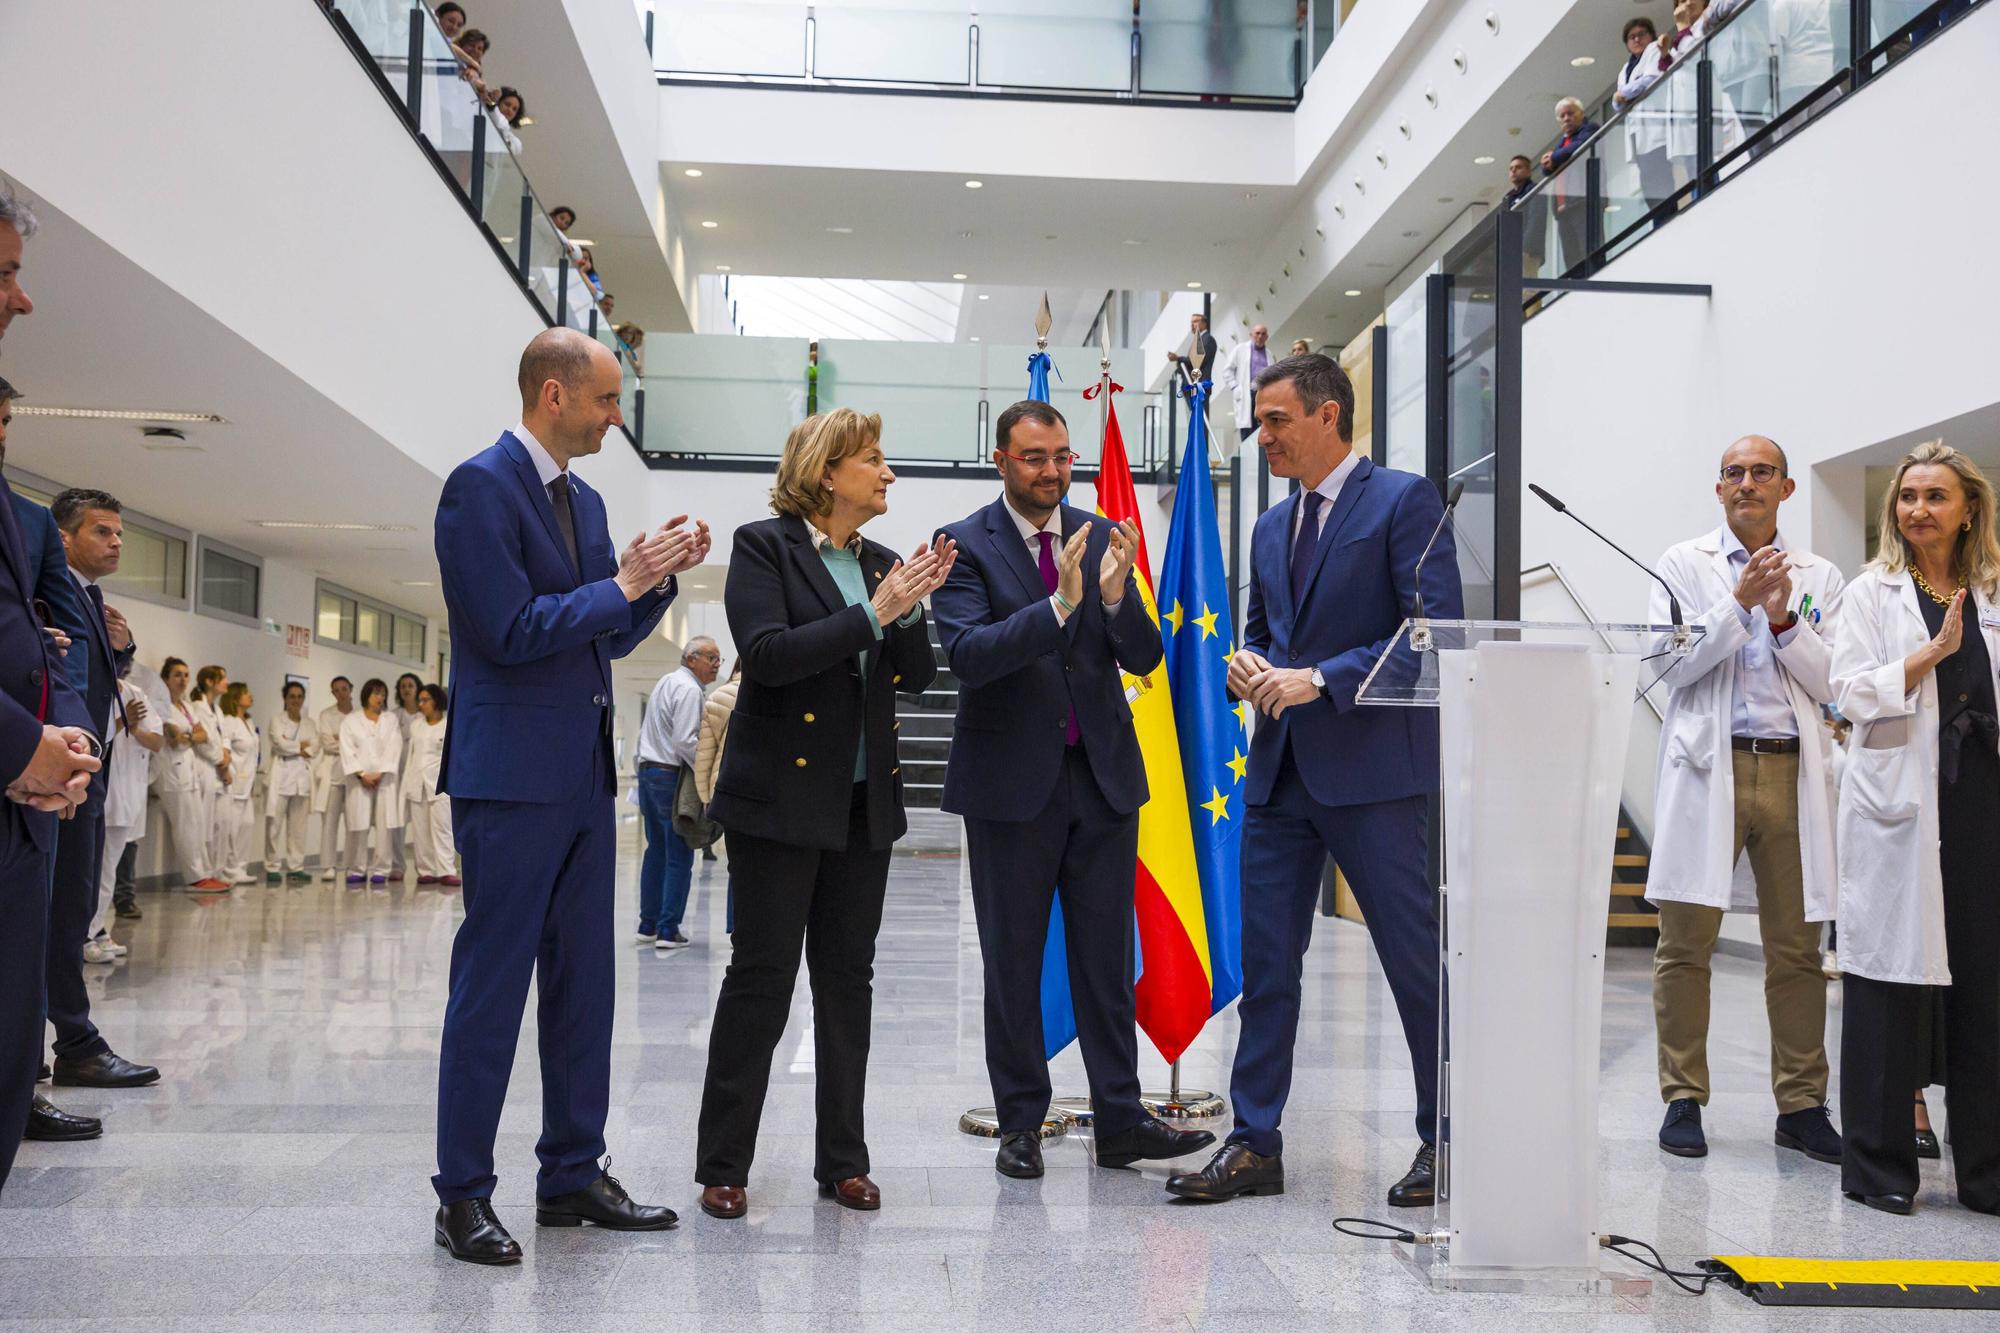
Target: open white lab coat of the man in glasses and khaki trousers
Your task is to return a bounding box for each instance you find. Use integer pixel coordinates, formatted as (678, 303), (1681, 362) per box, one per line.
(1646, 528), (1846, 912)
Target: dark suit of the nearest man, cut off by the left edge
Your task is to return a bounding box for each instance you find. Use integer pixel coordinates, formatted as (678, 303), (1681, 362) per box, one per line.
(0, 480), (84, 1187)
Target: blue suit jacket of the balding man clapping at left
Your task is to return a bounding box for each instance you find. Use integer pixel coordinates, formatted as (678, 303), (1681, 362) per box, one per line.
(436, 430), (676, 803)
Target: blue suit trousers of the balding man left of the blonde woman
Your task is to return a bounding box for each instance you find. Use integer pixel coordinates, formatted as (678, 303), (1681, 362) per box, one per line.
(430, 765), (618, 1203)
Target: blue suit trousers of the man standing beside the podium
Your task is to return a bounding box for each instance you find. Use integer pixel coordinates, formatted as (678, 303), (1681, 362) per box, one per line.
(1230, 749), (1438, 1157)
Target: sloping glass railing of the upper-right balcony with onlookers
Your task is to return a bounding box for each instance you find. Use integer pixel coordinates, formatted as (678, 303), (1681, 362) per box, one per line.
(1514, 0), (1986, 278)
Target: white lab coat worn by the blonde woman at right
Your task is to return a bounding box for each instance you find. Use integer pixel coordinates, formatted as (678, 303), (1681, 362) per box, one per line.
(1834, 568), (2000, 987)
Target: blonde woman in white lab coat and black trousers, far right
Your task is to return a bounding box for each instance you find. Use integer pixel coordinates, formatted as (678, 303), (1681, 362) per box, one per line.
(1834, 442), (2000, 1213)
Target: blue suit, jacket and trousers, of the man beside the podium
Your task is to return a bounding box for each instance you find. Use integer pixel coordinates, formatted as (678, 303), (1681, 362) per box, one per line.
(1230, 458), (1464, 1155)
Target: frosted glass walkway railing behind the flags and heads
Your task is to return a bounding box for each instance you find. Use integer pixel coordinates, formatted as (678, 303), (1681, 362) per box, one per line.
(628, 334), (1164, 472)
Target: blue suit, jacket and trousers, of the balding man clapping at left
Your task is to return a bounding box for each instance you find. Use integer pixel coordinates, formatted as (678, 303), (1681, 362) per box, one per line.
(432, 432), (674, 1203)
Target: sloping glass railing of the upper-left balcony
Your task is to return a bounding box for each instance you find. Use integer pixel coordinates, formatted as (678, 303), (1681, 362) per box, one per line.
(326, 0), (630, 342)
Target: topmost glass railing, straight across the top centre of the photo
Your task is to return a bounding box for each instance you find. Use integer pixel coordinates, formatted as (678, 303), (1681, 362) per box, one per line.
(638, 0), (1320, 102)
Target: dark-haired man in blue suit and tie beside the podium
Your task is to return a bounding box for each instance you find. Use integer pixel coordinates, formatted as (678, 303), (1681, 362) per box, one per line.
(1166, 352), (1464, 1207)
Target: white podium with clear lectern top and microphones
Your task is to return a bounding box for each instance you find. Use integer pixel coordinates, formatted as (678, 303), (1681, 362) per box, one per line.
(1358, 620), (1700, 1295)
